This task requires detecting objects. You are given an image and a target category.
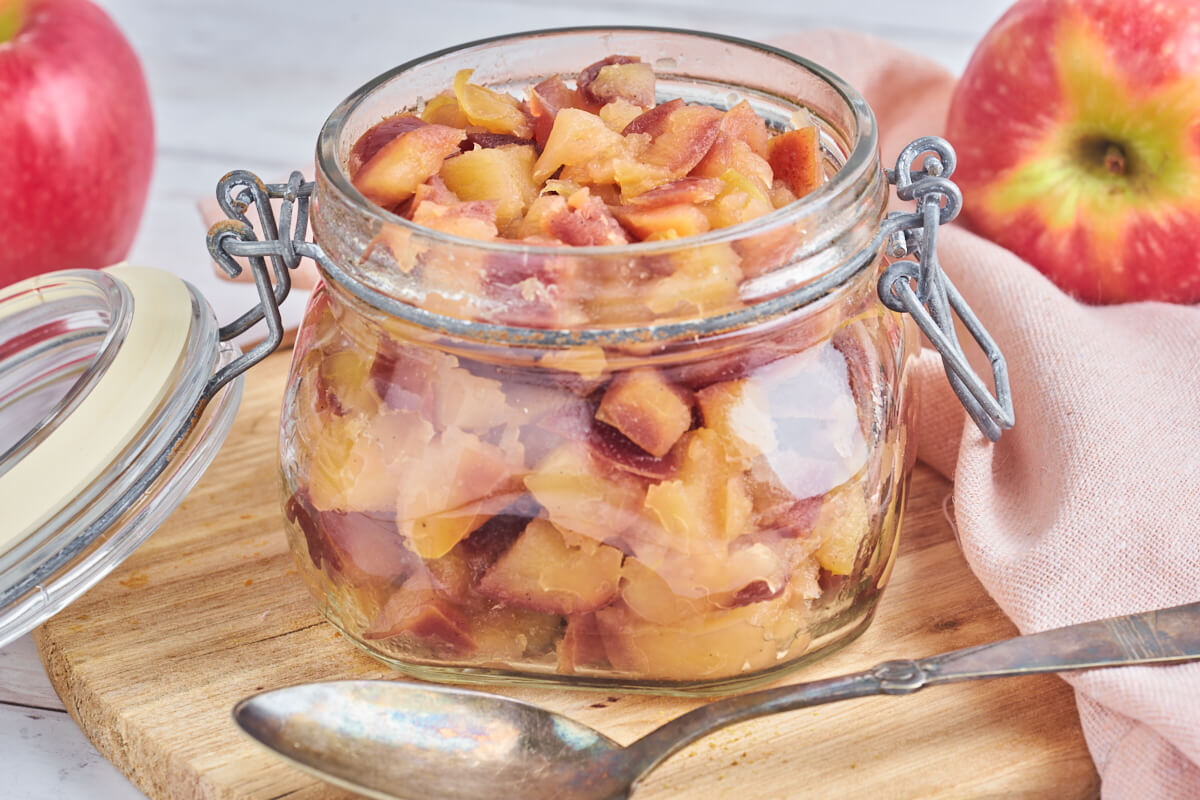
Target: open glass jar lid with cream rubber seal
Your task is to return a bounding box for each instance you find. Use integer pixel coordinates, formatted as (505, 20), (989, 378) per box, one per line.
(0, 265), (241, 645)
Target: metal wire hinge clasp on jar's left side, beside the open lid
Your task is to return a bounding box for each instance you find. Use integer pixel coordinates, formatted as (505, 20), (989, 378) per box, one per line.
(204, 169), (316, 402)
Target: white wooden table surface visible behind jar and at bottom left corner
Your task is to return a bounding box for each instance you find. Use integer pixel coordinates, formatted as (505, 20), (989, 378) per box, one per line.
(0, 0), (1009, 800)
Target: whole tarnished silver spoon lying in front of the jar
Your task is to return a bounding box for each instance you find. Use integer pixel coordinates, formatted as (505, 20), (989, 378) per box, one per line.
(233, 602), (1200, 800)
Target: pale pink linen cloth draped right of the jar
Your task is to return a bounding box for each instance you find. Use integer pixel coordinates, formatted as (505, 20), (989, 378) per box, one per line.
(776, 31), (1200, 800)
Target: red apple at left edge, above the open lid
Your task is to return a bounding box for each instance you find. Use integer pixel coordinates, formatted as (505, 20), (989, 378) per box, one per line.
(0, 0), (154, 285)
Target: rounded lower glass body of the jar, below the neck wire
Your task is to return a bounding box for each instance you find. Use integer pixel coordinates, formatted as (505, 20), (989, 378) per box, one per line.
(281, 272), (913, 691)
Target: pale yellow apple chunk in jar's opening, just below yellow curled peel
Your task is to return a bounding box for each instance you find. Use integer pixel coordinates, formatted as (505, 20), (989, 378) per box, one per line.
(439, 145), (538, 230)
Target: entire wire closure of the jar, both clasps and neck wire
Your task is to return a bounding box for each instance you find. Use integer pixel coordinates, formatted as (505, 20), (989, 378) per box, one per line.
(203, 137), (1014, 441)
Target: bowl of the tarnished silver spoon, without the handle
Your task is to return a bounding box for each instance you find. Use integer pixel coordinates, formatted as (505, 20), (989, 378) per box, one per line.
(234, 680), (632, 800)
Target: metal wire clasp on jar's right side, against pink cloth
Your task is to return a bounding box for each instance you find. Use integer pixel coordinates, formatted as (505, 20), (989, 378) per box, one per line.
(878, 137), (1014, 441)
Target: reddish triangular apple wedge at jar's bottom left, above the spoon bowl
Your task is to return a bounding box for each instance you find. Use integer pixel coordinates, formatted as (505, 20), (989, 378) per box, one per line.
(362, 571), (475, 652)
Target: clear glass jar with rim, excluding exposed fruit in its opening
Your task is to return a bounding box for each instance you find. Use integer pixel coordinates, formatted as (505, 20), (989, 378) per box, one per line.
(267, 29), (969, 693)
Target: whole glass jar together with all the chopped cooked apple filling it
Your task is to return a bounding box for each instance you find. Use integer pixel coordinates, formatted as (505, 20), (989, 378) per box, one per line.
(281, 31), (913, 692)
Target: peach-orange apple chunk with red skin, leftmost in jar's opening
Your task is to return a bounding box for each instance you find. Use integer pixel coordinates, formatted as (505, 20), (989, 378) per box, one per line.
(354, 125), (467, 207)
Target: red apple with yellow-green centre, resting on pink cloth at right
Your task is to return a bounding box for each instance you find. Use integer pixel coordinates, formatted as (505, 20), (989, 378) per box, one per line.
(946, 0), (1200, 303)
